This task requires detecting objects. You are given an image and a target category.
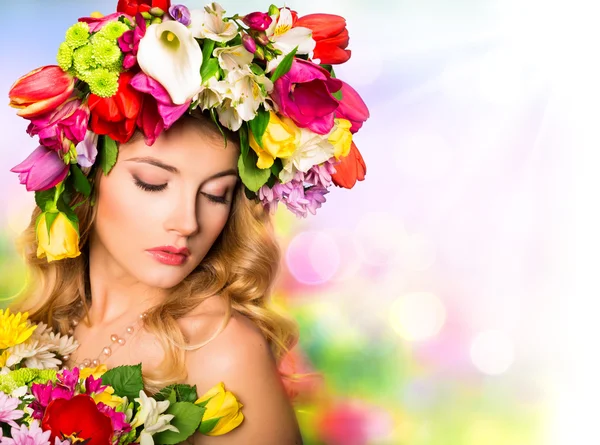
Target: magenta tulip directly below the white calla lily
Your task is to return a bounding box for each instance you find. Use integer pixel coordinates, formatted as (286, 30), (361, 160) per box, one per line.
(129, 72), (191, 145)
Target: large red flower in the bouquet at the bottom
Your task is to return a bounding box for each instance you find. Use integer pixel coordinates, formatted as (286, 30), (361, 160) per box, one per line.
(42, 394), (114, 445)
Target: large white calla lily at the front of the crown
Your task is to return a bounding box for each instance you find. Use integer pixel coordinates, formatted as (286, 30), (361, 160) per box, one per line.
(137, 20), (202, 105)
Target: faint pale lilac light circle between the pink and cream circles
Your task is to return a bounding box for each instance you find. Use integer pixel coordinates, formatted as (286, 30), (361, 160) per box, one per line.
(356, 212), (406, 266)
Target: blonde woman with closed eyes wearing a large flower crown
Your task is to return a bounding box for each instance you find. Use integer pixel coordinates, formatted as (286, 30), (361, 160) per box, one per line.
(9, 0), (368, 445)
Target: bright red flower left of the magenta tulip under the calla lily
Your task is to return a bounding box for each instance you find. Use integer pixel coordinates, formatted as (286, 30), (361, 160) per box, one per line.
(88, 71), (142, 142)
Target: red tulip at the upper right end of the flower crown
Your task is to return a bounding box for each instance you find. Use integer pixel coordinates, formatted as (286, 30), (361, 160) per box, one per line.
(294, 14), (351, 65)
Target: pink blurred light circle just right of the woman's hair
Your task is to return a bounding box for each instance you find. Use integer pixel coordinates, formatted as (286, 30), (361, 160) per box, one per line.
(286, 231), (340, 284)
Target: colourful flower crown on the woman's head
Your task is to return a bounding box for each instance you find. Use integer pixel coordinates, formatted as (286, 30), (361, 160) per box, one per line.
(9, 0), (369, 261)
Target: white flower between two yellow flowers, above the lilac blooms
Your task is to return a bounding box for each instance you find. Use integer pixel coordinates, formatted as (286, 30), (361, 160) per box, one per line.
(279, 123), (335, 184)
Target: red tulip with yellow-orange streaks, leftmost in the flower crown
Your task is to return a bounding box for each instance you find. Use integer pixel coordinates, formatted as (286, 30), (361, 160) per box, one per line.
(8, 65), (75, 119)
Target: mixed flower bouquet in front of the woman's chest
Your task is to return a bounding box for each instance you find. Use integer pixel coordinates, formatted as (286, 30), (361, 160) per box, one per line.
(0, 309), (244, 445)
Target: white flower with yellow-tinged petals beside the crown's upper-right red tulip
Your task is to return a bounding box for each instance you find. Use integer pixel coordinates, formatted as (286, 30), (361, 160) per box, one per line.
(265, 8), (317, 73)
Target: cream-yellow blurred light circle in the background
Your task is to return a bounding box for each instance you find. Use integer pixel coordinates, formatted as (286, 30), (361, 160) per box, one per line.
(390, 292), (446, 341)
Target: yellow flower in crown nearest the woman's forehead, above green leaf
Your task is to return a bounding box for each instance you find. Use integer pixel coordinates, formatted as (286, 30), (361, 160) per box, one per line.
(249, 111), (298, 168)
